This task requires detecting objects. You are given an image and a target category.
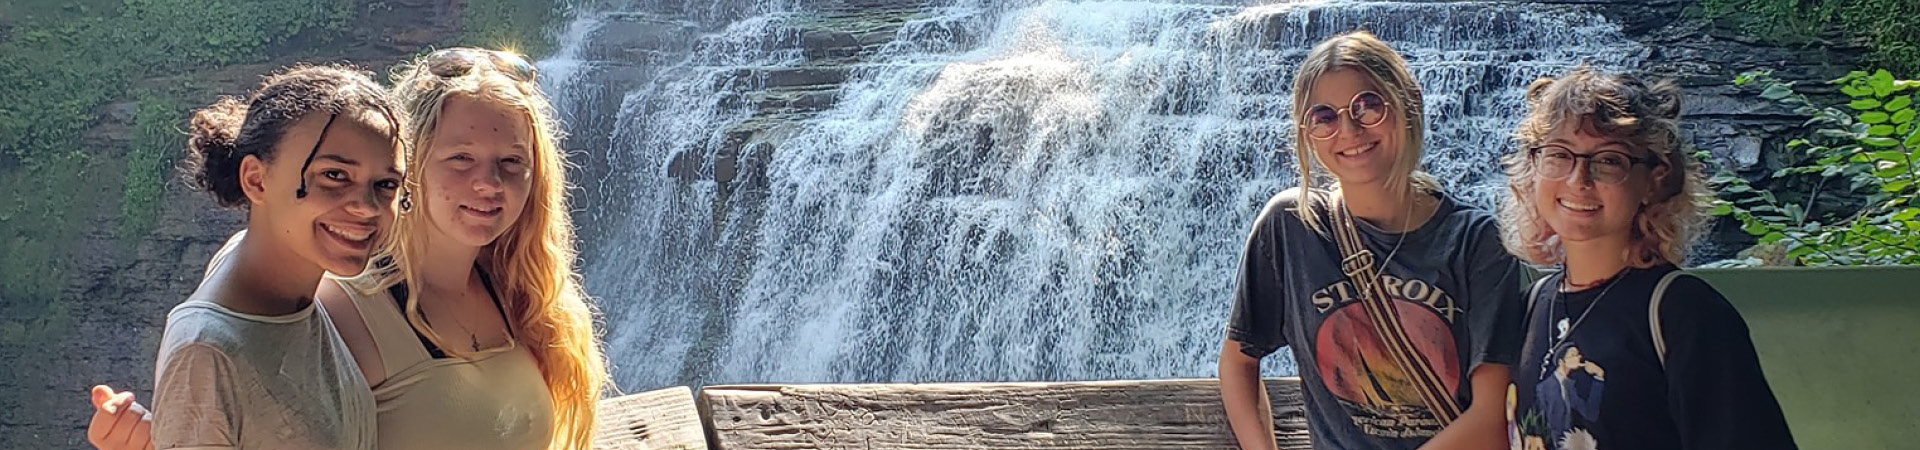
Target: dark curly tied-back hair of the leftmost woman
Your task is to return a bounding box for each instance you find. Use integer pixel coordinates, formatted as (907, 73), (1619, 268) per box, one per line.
(180, 65), (403, 208)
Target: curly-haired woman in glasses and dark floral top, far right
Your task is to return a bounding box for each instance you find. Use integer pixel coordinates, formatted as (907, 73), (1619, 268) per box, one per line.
(1501, 67), (1793, 448)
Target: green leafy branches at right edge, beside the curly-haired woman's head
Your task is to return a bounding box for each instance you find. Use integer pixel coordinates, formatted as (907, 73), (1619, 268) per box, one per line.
(1713, 69), (1920, 265)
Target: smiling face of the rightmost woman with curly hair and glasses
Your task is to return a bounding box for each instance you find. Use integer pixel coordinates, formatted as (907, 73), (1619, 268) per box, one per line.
(1532, 121), (1665, 246)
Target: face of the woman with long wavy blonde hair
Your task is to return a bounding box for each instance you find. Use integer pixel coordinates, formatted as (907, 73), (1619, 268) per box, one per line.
(420, 96), (534, 246)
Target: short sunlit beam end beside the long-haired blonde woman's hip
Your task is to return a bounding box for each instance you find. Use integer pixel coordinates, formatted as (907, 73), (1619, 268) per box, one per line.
(593, 387), (707, 450)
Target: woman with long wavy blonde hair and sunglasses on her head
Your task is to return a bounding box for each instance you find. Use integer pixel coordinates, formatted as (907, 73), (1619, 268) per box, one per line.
(319, 48), (607, 448)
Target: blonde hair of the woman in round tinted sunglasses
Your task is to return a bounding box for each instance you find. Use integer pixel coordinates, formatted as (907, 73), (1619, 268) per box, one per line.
(1292, 31), (1440, 231)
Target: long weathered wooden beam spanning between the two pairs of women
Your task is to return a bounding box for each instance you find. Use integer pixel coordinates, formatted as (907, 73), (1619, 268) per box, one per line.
(701, 379), (1309, 450)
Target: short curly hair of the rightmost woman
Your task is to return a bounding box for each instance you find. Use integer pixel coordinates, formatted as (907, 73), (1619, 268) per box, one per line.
(1500, 65), (1711, 267)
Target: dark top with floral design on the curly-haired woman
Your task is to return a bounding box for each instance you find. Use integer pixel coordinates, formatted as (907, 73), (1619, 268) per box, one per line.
(1507, 265), (1795, 450)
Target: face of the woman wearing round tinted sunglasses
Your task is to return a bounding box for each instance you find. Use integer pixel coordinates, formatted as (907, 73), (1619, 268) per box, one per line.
(1296, 69), (1407, 185)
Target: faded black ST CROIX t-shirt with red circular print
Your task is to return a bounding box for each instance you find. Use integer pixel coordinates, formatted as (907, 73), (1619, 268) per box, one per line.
(1227, 188), (1526, 450)
